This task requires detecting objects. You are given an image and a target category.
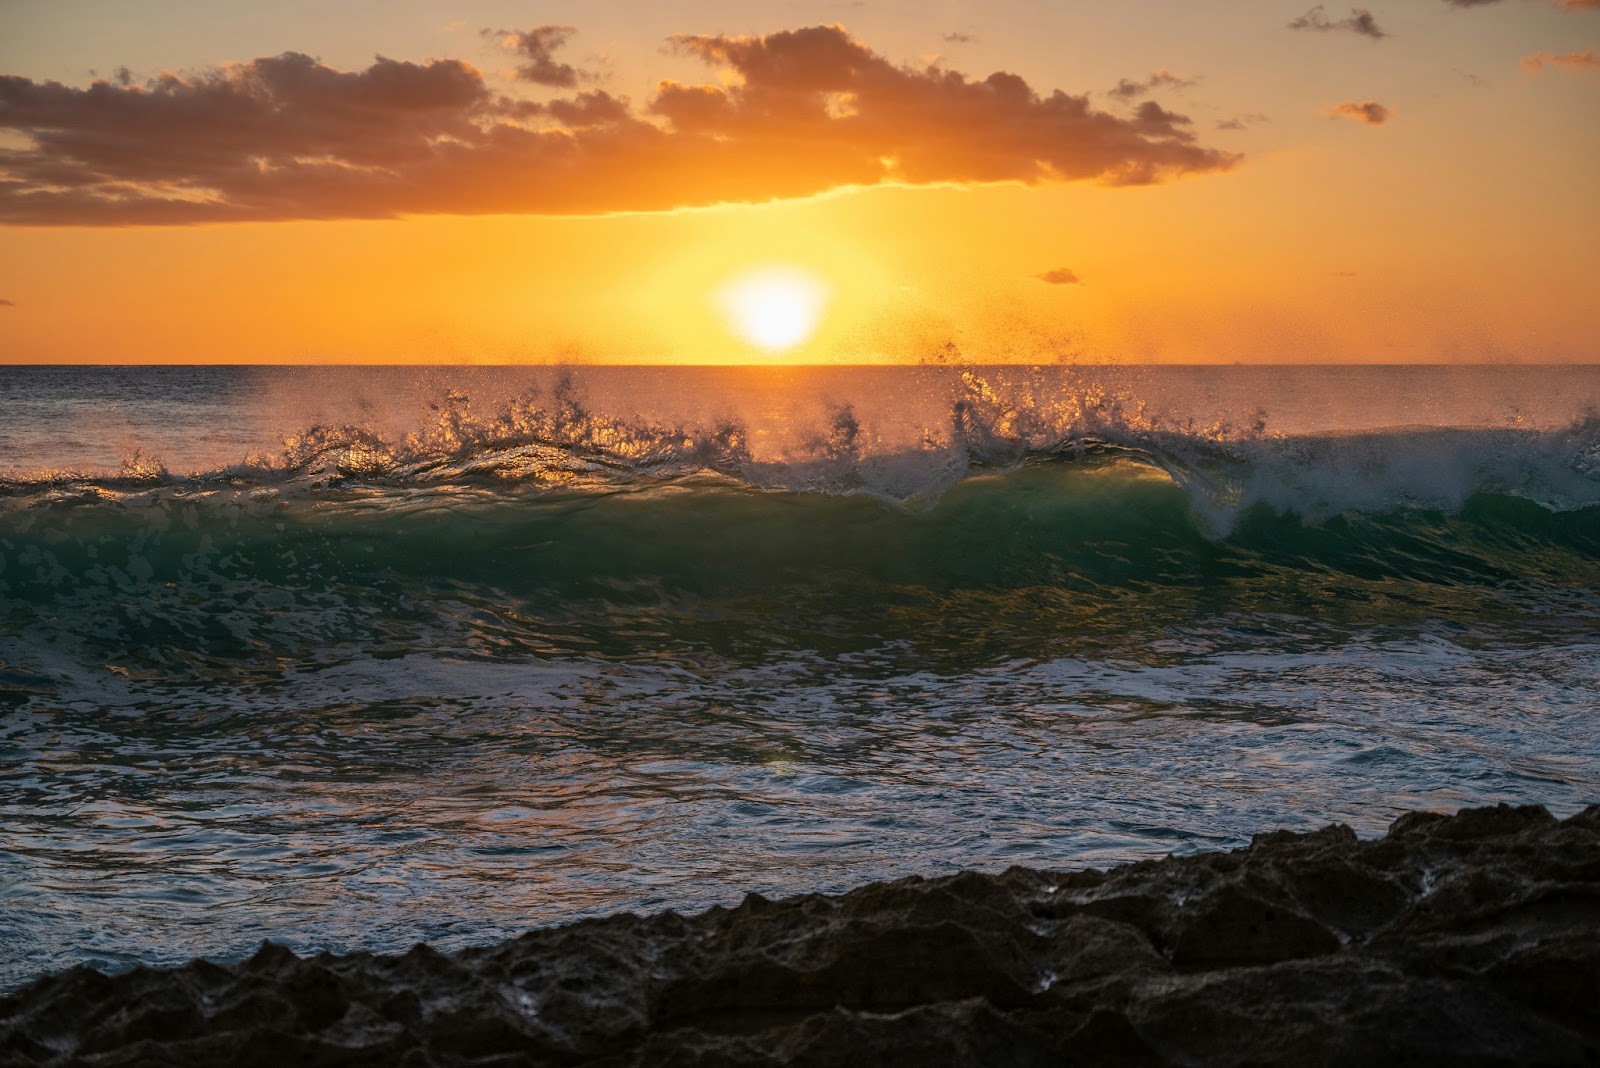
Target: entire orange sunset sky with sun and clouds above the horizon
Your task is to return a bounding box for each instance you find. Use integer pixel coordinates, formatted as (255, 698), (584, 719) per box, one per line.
(0, 0), (1600, 363)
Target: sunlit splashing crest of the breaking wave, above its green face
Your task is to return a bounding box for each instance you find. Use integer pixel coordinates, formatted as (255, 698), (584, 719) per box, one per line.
(0, 371), (1600, 536)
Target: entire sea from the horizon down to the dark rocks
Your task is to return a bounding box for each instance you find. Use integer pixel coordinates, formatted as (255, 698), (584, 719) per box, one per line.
(0, 366), (1600, 990)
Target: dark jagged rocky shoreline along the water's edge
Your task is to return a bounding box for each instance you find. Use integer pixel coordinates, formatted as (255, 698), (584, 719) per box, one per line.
(0, 806), (1600, 1066)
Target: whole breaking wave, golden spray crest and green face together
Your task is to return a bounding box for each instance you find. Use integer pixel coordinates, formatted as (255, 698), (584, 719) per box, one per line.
(0, 374), (1600, 699)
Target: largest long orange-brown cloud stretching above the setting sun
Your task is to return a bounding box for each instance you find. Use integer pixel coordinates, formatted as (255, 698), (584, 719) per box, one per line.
(0, 26), (1240, 225)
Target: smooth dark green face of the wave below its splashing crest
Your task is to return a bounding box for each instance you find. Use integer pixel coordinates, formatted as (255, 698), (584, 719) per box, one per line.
(0, 456), (1600, 689)
